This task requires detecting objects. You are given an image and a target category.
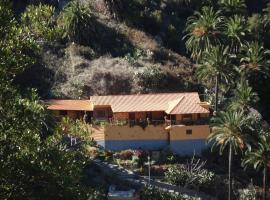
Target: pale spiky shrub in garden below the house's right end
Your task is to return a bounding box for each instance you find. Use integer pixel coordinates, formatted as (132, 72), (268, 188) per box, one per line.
(165, 157), (214, 188)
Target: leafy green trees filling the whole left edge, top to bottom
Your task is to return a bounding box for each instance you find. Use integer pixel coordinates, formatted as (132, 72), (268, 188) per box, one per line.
(0, 1), (101, 200)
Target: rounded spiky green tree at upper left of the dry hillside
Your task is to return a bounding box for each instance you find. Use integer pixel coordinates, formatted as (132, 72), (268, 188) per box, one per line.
(58, 1), (95, 44)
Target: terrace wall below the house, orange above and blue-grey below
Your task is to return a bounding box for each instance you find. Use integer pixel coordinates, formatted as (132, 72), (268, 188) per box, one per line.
(90, 125), (210, 155)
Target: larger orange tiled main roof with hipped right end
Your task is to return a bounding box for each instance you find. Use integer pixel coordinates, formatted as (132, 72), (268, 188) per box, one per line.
(90, 92), (209, 114)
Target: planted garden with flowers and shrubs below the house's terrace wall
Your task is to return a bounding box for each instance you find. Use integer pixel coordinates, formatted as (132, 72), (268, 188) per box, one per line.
(82, 143), (260, 200)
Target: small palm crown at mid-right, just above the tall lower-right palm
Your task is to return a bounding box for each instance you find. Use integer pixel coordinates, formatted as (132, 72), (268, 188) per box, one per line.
(229, 74), (258, 112)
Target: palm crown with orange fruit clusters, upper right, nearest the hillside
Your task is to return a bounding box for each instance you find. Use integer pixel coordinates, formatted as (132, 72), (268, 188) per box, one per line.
(184, 7), (224, 61)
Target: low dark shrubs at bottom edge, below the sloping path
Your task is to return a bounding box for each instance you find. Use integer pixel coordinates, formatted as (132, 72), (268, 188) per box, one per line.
(140, 188), (199, 200)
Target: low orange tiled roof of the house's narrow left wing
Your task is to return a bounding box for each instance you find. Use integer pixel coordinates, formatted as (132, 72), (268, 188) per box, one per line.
(45, 99), (93, 111)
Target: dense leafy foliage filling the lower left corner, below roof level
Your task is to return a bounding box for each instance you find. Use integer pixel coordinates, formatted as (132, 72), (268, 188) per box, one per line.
(0, 85), (92, 199)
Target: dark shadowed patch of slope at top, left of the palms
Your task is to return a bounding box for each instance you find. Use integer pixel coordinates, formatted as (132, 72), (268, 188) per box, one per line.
(105, 0), (194, 55)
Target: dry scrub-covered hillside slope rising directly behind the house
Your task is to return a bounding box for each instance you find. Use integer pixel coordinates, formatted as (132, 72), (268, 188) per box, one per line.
(13, 1), (200, 99)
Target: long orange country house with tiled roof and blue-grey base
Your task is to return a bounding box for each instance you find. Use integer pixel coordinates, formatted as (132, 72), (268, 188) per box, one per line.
(47, 92), (210, 155)
